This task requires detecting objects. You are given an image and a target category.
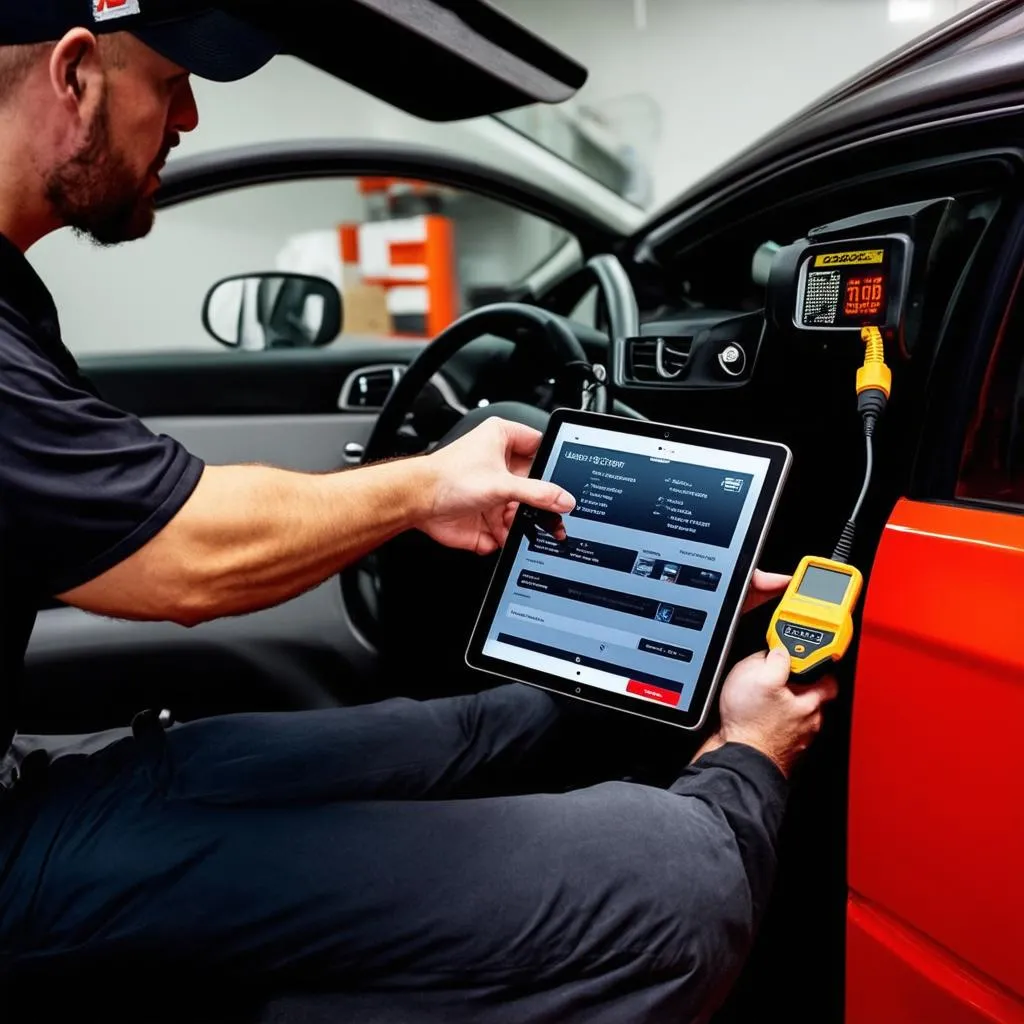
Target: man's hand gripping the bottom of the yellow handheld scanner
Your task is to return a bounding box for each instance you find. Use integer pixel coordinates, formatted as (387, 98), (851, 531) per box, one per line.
(694, 648), (839, 777)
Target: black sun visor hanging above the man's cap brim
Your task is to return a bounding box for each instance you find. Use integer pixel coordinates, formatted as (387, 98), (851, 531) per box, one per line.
(218, 0), (587, 121)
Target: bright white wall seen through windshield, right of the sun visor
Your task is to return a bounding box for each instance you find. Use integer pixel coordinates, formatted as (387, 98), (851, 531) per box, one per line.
(497, 0), (975, 205)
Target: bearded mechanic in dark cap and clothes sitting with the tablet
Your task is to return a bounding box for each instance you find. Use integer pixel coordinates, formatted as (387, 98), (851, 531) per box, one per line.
(0, 8), (836, 1024)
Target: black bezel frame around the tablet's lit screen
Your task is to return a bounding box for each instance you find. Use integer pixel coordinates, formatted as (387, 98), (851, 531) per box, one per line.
(466, 409), (793, 730)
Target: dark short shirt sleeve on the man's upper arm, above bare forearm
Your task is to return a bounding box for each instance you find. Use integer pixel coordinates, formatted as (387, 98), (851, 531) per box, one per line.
(0, 323), (204, 598)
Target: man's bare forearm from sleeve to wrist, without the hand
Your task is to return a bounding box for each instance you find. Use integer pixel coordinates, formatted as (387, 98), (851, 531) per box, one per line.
(60, 459), (430, 626)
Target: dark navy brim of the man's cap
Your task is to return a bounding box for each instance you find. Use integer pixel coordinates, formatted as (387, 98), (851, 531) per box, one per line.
(132, 10), (279, 82)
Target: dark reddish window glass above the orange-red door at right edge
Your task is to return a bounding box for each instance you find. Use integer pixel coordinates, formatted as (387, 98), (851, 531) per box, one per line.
(956, 272), (1024, 511)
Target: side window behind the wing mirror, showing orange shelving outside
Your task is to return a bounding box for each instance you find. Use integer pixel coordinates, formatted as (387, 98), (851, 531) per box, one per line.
(29, 178), (573, 355)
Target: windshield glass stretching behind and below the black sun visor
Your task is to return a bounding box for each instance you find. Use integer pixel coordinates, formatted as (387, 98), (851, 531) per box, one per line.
(177, 0), (974, 274)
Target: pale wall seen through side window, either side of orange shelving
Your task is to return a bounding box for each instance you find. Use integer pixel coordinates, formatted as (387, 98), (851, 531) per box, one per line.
(29, 179), (566, 355)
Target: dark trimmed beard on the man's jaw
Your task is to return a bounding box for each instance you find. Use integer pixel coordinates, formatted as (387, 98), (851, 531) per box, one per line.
(46, 96), (170, 246)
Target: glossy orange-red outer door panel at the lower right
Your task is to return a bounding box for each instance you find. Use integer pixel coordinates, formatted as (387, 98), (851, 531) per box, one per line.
(847, 501), (1024, 1024)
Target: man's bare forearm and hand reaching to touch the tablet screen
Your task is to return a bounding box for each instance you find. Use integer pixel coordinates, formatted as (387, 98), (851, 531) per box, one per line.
(60, 420), (574, 626)
